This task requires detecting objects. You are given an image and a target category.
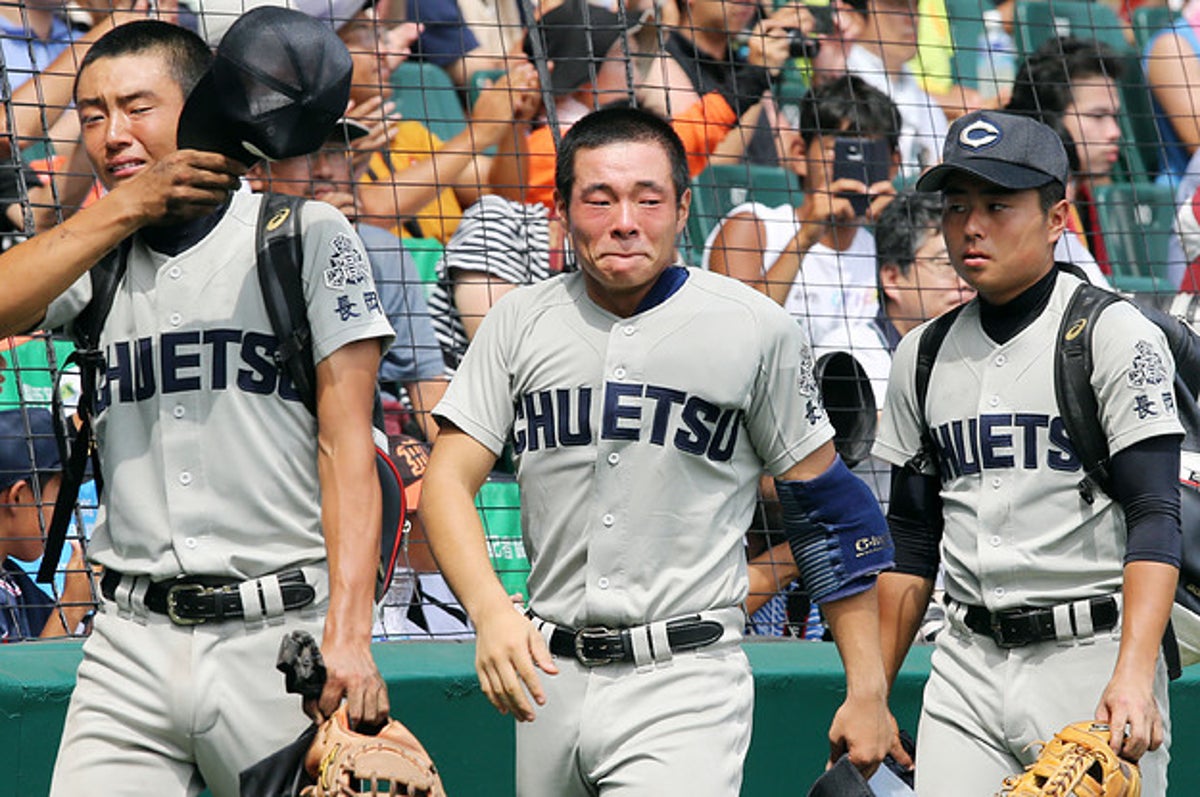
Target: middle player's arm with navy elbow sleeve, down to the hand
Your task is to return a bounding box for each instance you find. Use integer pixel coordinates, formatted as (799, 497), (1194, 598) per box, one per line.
(775, 442), (908, 775)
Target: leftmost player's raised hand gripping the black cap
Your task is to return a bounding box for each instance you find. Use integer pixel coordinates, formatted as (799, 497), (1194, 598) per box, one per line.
(120, 150), (246, 224)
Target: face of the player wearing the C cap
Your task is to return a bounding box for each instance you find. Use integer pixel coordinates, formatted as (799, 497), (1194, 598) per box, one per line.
(942, 173), (1067, 305)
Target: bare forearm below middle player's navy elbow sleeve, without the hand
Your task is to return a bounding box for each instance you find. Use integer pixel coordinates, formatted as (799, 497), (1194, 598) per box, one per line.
(821, 587), (888, 701)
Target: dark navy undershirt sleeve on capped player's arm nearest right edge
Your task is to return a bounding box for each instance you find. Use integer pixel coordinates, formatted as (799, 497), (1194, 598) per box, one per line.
(1110, 436), (1183, 567)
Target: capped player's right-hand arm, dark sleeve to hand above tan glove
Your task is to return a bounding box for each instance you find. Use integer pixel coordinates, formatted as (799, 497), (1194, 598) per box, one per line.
(1096, 436), (1182, 761)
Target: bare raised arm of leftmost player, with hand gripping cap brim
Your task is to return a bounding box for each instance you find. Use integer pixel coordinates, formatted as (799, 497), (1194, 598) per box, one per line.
(0, 150), (245, 336)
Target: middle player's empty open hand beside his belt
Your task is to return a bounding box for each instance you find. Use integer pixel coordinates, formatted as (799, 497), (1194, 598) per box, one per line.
(475, 603), (558, 723)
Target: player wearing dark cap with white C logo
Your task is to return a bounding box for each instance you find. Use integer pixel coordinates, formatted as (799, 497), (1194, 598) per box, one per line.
(875, 112), (1181, 797)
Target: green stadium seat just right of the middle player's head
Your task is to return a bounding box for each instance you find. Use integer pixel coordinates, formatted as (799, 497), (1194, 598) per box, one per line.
(688, 163), (804, 264)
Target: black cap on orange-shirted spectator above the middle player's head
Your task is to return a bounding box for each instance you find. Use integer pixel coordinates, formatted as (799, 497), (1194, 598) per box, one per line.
(524, 0), (637, 94)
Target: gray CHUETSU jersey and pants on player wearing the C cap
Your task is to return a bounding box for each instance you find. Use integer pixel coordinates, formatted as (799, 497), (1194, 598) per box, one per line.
(875, 274), (1182, 797)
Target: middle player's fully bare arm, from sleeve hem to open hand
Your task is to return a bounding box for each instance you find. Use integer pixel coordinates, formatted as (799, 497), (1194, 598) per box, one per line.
(420, 424), (558, 721)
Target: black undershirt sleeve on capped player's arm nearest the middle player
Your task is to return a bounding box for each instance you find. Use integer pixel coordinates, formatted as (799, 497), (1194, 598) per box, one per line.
(888, 466), (943, 579)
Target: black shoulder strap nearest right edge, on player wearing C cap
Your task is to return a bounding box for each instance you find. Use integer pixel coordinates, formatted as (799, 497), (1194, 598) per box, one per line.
(1054, 284), (1123, 503)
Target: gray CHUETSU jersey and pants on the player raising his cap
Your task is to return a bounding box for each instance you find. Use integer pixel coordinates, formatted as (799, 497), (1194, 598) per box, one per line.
(47, 188), (391, 797)
